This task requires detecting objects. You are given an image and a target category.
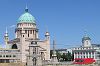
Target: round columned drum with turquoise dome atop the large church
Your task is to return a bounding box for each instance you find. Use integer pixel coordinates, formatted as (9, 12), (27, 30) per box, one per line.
(15, 7), (38, 39)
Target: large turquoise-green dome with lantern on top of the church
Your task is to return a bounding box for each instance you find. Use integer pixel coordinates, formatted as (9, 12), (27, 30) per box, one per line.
(18, 8), (35, 23)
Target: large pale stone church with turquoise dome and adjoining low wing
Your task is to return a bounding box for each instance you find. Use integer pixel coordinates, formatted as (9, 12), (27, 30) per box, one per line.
(0, 7), (50, 63)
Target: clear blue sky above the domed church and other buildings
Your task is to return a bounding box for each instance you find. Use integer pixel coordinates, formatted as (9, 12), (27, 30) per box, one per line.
(0, 0), (100, 48)
